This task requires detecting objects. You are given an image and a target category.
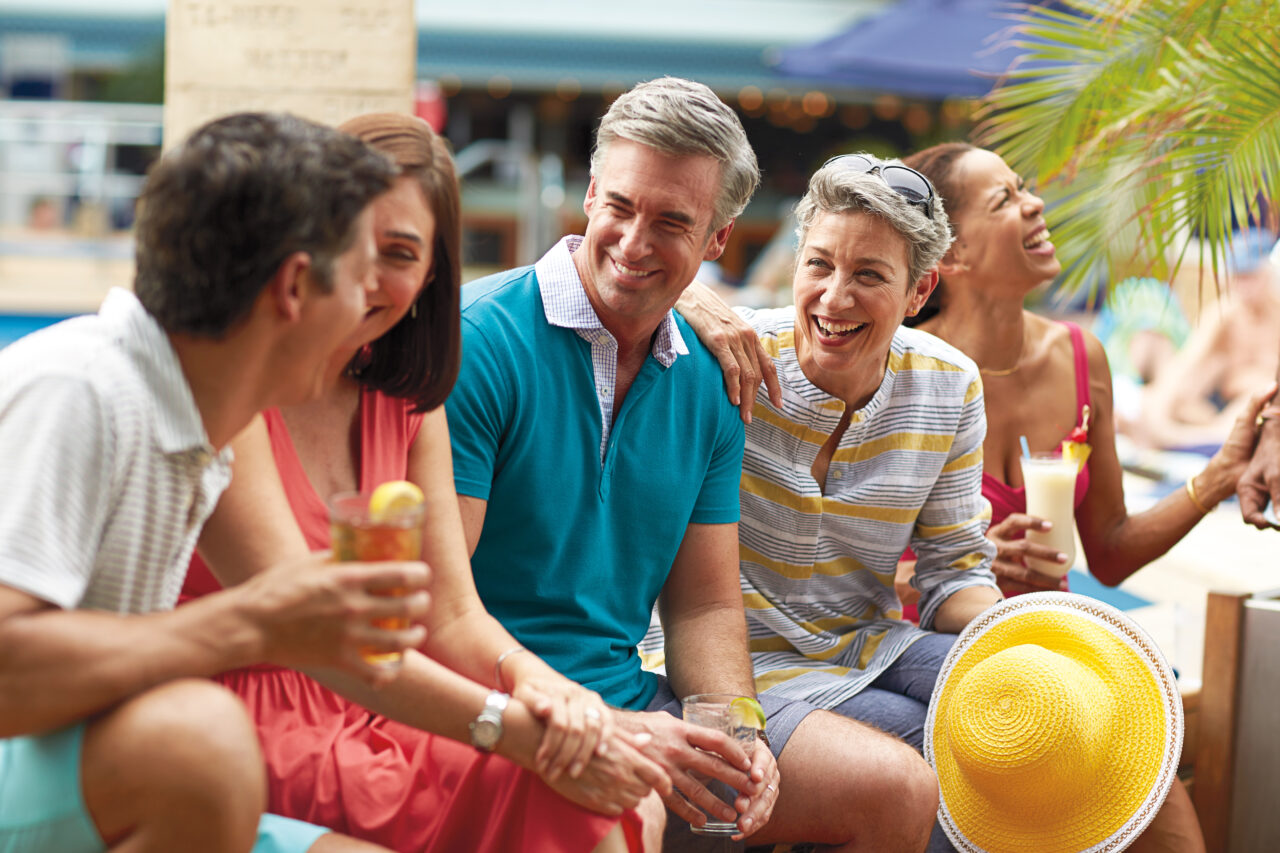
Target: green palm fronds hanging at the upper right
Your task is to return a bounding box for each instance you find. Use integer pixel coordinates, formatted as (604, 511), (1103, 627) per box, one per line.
(977, 0), (1280, 298)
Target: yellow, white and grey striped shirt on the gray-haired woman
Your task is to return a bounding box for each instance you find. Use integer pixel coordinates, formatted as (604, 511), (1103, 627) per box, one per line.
(739, 307), (996, 708)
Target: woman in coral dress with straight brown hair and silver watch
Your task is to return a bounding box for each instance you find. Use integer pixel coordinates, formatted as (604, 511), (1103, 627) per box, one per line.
(183, 114), (669, 853)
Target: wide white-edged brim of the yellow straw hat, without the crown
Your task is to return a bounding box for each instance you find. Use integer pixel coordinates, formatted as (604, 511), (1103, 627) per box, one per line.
(924, 592), (1183, 853)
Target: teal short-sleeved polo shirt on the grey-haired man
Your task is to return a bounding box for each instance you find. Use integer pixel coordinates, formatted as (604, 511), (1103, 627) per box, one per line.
(445, 261), (744, 710)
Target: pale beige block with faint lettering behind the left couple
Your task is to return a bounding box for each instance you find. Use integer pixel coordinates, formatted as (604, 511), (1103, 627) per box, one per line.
(164, 0), (417, 147)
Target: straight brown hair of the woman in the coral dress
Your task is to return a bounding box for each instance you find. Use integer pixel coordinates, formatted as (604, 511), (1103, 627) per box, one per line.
(338, 113), (462, 411)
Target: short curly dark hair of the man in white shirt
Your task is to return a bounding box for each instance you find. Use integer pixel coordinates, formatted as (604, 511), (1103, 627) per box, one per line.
(134, 113), (397, 338)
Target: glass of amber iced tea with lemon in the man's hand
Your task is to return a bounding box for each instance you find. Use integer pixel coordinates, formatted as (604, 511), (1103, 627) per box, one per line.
(329, 492), (426, 669)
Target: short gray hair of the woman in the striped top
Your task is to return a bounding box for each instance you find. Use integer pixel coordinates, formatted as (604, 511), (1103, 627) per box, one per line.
(796, 155), (952, 283)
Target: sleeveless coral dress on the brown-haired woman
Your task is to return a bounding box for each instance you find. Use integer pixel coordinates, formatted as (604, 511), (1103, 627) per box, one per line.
(183, 391), (640, 853)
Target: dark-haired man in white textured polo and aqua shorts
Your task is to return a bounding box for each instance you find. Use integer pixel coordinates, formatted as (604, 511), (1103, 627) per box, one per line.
(0, 114), (428, 853)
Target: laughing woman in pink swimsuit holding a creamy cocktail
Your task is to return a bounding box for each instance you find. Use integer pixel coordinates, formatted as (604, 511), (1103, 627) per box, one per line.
(905, 142), (1271, 594)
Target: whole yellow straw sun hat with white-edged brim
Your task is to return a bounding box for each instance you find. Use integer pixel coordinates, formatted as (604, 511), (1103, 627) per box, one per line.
(924, 592), (1183, 853)
